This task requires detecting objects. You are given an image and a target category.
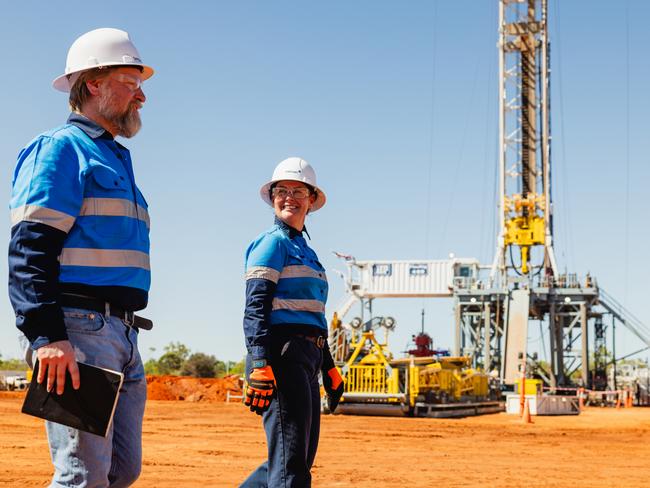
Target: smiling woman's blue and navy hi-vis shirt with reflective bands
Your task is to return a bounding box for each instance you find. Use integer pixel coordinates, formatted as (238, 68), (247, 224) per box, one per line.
(244, 217), (328, 359)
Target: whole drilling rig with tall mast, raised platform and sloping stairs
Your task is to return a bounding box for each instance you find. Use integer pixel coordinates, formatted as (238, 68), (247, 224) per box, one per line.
(454, 0), (650, 390)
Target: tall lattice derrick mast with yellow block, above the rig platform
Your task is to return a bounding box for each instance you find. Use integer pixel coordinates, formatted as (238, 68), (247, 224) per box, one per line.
(490, 0), (557, 286)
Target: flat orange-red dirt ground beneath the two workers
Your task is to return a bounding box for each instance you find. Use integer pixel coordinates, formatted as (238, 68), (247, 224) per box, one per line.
(0, 380), (650, 488)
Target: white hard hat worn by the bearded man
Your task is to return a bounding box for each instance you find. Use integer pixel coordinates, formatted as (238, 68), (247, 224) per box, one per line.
(52, 27), (153, 92)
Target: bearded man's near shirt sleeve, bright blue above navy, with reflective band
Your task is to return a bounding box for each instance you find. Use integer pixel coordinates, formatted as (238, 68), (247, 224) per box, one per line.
(8, 137), (83, 349)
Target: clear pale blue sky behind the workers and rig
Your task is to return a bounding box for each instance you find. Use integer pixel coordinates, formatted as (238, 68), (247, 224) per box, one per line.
(0, 0), (650, 360)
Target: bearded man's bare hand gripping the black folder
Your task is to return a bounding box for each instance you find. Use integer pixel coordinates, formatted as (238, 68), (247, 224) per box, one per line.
(36, 341), (81, 395)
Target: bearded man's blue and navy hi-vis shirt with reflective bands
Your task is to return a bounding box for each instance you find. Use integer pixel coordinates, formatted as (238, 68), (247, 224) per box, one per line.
(9, 113), (151, 348)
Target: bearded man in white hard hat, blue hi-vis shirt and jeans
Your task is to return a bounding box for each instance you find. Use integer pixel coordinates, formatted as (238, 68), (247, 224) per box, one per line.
(9, 29), (153, 487)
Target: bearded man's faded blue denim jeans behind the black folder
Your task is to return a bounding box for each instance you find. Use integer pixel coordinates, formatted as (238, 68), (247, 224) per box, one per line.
(45, 307), (147, 488)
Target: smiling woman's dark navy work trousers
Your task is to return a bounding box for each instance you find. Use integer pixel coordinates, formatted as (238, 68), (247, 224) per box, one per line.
(240, 337), (323, 488)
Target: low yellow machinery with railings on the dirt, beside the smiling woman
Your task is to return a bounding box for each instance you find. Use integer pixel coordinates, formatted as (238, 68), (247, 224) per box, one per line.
(332, 319), (502, 417)
